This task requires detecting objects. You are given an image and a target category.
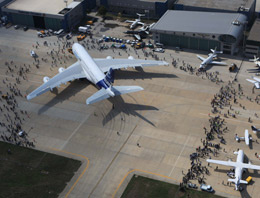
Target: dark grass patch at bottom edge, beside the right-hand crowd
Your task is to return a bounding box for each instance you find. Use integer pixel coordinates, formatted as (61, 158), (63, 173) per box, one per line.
(121, 175), (224, 198)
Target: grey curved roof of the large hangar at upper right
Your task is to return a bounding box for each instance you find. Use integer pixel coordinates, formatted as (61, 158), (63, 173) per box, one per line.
(152, 10), (247, 37)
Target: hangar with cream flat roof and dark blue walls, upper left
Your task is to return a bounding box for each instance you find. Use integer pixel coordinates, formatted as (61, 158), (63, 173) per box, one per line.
(2, 0), (86, 30)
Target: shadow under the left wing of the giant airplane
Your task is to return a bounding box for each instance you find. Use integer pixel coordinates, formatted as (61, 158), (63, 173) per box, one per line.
(38, 79), (90, 115)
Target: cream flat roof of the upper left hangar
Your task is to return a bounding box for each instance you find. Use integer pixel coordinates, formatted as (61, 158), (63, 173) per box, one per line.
(6, 0), (79, 15)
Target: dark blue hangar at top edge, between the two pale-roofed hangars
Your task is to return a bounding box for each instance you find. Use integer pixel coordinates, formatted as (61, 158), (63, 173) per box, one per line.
(97, 0), (174, 18)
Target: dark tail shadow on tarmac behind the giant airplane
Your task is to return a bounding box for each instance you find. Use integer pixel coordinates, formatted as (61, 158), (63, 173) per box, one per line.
(102, 95), (159, 127)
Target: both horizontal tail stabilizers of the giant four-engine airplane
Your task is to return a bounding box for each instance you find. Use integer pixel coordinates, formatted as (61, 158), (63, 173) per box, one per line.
(86, 86), (143, 105)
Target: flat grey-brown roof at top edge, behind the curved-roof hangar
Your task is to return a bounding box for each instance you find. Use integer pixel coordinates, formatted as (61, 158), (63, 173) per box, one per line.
(175, 0), (255, 12)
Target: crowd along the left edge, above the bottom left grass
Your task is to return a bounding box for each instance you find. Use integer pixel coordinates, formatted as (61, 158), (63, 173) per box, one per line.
(0, 61), (35, 147)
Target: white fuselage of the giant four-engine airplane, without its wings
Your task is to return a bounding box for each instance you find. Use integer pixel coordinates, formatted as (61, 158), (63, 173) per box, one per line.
(72, 43), (115, 96)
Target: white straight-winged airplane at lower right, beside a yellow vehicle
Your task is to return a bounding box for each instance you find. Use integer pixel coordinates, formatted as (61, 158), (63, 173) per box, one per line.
(207, 150), (260, 190)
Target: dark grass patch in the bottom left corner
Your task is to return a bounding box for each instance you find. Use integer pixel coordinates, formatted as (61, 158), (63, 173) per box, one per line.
(0, 142), (81, 198)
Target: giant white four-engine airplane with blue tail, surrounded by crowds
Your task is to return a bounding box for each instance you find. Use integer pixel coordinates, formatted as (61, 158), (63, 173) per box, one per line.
(27, 43), (168, 104)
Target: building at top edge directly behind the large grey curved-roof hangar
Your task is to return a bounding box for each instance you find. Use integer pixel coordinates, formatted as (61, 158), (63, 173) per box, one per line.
(174, 0), (256, 21)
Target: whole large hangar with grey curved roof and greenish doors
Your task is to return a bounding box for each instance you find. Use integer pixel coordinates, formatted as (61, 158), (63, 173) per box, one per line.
(151, 10), (247, 55)
